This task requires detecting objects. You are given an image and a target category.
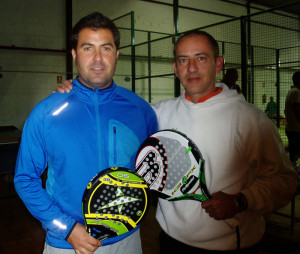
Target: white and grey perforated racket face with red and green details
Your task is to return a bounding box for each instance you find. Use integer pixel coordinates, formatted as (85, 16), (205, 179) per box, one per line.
(136, 130), (210, 201)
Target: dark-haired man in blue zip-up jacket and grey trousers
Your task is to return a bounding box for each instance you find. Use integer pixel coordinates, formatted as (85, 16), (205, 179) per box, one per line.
(14, 13), (157, 254)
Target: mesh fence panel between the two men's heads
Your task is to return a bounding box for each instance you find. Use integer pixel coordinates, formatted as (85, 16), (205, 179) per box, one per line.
(135, 32), (174, 102)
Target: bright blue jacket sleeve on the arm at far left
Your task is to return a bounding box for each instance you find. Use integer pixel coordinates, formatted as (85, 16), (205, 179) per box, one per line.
(14, 109), (76, 239)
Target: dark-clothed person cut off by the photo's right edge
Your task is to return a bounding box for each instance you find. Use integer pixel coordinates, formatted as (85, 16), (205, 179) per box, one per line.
(284, 71), (300, 172)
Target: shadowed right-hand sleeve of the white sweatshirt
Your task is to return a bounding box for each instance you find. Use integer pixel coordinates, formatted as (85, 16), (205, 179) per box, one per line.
(241, 115), (297, 214)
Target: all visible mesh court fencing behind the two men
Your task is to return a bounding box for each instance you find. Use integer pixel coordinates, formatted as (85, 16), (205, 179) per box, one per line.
(134, 2), (300, 146)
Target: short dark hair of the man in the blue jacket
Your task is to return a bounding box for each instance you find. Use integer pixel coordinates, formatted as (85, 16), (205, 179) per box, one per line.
(71, 12), (120, 50)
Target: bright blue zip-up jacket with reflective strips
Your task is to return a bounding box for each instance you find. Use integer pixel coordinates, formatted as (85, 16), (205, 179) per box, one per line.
(14, 79), (157, 248)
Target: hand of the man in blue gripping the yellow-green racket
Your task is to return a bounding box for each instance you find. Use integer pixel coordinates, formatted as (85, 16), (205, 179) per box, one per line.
(67, 223), (102, 254)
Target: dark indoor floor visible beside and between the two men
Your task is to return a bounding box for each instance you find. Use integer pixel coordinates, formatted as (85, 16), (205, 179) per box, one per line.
(0, 175), (300, 254)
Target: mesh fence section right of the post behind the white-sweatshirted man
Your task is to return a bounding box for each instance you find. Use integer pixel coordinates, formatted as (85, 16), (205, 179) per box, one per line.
(247, 3), (300, 146)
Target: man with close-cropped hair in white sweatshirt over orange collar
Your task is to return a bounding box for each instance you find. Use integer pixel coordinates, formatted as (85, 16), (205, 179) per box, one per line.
(57, 31), (297, 254)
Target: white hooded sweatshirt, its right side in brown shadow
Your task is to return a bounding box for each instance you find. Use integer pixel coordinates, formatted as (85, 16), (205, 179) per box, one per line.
(153, 84), (296, 250)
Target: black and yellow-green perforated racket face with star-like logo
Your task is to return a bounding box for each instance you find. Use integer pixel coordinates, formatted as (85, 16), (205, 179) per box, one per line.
(82, 167), (150, 241)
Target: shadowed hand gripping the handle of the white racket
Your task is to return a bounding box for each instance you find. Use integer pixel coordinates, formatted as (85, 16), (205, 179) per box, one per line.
(202, 191), (239, 220)
